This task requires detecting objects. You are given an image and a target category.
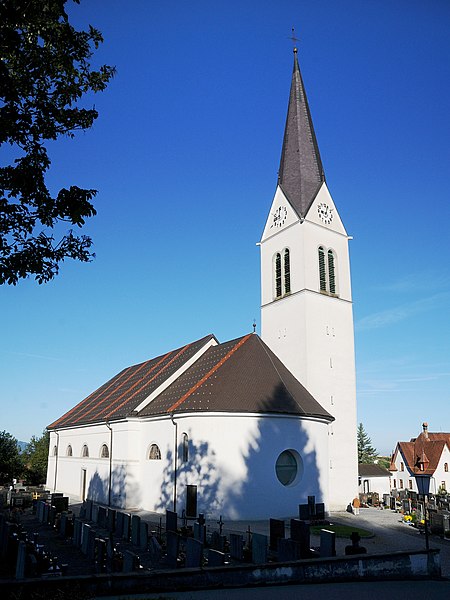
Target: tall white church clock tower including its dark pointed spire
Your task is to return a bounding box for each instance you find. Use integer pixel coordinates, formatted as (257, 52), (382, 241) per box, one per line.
(260, 48), (358, 510)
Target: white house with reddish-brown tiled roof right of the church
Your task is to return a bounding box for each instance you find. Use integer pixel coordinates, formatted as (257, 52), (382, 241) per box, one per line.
(389, 423), (450, 494)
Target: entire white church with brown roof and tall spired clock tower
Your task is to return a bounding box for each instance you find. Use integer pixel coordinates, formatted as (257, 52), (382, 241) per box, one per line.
(47, 48), (358, 519)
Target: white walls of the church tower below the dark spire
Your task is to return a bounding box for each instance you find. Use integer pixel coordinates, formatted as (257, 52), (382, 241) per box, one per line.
(261, 183), (358, 510)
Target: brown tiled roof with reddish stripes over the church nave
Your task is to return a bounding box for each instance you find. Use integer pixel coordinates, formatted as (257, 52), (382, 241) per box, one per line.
(49, 334), (333, 429)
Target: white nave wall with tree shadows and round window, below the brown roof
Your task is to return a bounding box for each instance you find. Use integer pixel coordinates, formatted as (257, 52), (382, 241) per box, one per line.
(47, 413), (328, 519)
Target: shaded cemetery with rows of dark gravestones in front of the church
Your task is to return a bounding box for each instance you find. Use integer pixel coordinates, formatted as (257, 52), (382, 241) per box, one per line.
(0, 493), (440, 597)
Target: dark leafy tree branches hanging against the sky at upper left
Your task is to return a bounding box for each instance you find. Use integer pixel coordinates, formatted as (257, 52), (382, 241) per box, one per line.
(0, 0), (114, 285)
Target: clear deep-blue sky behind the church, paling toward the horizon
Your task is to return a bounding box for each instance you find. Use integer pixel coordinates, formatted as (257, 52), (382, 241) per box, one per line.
(0, 0), (450, 453)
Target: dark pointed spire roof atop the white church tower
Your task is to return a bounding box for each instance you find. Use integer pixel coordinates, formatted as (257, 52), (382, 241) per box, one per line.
(278, 48), (325, 217)
